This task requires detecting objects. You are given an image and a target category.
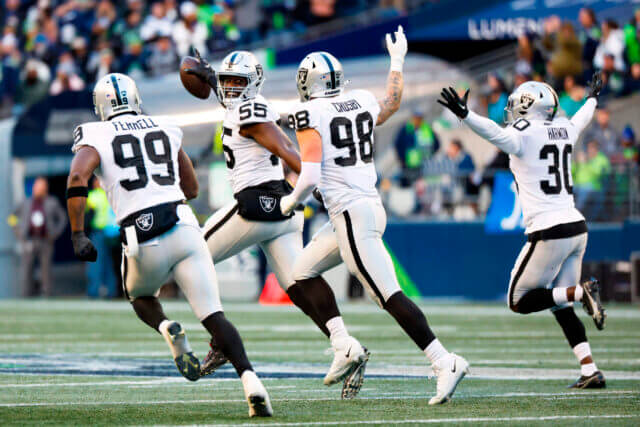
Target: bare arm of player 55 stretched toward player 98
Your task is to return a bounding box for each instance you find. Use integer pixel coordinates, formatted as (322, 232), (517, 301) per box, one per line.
(240, 122), (301, 174)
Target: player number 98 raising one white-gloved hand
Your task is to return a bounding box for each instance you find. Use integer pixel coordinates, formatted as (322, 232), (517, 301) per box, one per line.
(280, 27), (469, 405)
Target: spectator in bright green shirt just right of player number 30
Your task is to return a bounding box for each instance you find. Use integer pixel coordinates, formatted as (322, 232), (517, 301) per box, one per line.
(572, 141), (611, 221)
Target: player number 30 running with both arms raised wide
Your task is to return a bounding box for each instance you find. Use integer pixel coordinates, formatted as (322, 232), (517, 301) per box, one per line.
(438, 74), (605, 388)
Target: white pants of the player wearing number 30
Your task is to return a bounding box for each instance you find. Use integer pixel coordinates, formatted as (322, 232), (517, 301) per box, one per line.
(508, 233), (587, 310)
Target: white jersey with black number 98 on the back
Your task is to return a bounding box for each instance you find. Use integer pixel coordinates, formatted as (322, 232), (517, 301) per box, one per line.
(289, 90), (380, 217)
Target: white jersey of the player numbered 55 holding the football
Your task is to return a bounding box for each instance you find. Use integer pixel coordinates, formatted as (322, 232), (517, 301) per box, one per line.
(222, 95), (284, 193)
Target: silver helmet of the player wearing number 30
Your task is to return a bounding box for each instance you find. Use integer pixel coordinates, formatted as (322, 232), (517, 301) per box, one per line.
(504, 81), (558, 124)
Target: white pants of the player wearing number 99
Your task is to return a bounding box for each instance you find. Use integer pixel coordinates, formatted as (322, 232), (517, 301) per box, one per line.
(121, 205), (222, 321)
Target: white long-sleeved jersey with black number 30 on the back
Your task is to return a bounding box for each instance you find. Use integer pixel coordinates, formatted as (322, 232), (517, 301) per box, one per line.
(464, 98), (596, 234)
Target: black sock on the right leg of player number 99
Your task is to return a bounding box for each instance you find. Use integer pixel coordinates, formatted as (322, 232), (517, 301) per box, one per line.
(202, 311), (253, 377)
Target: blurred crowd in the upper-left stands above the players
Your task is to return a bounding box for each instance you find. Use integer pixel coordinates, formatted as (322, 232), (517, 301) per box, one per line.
(0, 0), (405, 117)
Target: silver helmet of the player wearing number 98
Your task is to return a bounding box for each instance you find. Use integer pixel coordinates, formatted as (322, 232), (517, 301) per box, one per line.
(296, 52), (348, 102)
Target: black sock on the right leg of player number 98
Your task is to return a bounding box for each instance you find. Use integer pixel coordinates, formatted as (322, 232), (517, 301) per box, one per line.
(384, 292), (436, 350)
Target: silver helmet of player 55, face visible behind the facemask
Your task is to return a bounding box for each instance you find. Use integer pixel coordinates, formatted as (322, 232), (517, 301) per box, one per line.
(216, 51), (265, 109)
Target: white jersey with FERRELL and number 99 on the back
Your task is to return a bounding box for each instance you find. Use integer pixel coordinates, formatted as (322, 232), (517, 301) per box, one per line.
(72, 114), (185, 223)
